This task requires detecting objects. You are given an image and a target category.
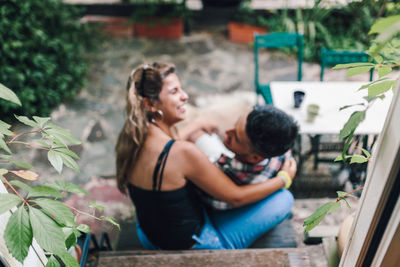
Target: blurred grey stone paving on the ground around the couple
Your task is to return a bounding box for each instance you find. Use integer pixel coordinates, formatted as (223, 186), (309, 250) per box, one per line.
(14, 24), (384, 266)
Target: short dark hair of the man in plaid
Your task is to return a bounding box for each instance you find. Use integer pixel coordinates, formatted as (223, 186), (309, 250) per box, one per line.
(246, 105), (299, 158)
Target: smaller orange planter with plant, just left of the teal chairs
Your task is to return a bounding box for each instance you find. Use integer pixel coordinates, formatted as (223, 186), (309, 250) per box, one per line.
(228, 0), (268, 43)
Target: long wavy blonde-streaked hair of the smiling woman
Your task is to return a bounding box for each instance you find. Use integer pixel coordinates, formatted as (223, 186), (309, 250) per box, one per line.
(115, 62), (175, 194)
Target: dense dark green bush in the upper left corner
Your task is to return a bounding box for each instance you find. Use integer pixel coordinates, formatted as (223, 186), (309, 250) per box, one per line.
(0, 0), (89, 121)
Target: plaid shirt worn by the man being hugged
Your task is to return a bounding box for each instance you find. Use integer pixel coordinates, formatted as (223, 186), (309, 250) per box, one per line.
(199, 151), (291, 210)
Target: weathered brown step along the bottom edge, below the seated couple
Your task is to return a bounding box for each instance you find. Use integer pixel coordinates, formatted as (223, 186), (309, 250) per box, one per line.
(98, 248), (310, 267)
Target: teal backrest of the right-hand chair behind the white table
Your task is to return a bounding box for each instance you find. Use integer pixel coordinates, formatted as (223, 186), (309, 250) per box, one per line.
(320, 47), (374, 81)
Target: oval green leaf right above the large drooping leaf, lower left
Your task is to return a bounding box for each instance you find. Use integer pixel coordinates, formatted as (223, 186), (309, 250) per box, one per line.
(33, 198), (76, 227)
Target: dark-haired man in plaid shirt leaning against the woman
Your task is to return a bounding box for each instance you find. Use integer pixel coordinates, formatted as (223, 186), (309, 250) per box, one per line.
(190, 105), (299, 210)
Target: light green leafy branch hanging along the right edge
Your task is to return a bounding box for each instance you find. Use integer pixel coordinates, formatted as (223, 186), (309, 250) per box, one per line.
(303, 16), (400, 232)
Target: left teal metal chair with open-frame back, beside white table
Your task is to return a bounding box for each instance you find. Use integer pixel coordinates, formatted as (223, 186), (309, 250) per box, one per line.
(254, 32), (303, 104)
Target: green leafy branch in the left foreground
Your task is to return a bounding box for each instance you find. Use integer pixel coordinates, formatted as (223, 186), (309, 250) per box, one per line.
(0, 84), (119, 266)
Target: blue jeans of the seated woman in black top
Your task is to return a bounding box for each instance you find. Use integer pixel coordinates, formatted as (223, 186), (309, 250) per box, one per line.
(136, 189), (294, 250)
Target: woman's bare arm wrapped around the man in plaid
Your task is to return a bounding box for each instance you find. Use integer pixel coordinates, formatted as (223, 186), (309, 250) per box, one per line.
(180, 142), (295, 206)
